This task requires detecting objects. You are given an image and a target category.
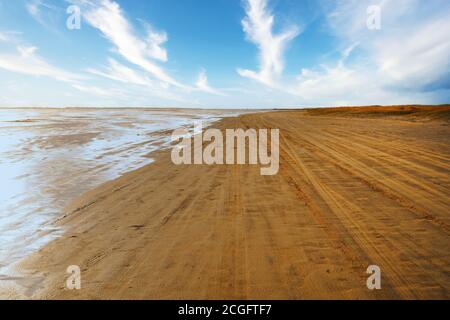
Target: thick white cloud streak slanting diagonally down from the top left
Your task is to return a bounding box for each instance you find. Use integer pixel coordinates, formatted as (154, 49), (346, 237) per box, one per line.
(82, 0), (185, 88)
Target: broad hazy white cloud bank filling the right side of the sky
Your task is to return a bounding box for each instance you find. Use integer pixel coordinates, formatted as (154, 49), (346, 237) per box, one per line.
(289, 0), (450, 104)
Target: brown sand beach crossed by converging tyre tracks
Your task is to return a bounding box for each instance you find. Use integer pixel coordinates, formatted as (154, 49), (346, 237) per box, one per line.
(14, 107), (450, 299)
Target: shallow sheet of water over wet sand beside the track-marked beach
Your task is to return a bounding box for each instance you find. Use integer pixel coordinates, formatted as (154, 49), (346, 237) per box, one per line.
(0, 109), (243, 298)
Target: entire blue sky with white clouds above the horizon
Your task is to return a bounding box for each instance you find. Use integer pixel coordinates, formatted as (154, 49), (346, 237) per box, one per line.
(0, 0), (450, 108)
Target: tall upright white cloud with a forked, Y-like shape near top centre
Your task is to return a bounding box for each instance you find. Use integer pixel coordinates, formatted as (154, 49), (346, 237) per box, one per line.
(238, 0), (299, 86)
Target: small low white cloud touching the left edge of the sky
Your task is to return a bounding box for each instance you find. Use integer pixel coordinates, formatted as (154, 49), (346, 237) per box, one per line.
(0, 46), (83, 82)
